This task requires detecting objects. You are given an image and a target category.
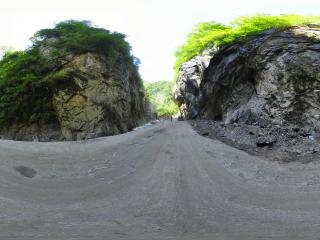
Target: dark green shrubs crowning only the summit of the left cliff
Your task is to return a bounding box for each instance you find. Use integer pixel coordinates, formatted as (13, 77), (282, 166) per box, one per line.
(31, 20), (131, 60)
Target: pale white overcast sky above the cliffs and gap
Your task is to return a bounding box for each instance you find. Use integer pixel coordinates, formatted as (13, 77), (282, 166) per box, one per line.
(0, 0), (320, 82)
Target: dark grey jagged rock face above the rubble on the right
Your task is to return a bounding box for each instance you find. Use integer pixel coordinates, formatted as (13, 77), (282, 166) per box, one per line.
(176, 26), (320, 128)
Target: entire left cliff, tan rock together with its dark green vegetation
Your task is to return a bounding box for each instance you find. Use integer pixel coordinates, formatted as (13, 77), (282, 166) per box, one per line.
(0, 21), (145, 141)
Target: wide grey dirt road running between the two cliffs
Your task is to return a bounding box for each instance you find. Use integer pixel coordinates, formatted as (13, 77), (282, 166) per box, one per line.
(0, 121), (320, 240)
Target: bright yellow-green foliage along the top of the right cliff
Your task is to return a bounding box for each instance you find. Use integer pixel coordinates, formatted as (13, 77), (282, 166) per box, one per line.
(175, 15), (320, 73)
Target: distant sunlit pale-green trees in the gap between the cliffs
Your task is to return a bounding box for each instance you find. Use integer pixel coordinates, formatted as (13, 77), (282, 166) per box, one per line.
(145, 81), (178, 117)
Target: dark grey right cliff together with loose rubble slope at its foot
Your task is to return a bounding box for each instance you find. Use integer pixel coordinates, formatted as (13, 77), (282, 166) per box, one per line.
(173, 25), (320, 161)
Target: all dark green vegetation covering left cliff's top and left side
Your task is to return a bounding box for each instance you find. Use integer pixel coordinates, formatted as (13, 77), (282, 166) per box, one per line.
(0, 20), (137, 127)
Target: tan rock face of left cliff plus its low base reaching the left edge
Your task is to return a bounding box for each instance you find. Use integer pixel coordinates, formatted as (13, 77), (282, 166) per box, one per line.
(1, 53), (145, 141)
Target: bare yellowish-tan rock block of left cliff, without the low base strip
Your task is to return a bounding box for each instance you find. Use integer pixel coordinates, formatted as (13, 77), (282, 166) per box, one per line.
(54, 53), (144, 140)
